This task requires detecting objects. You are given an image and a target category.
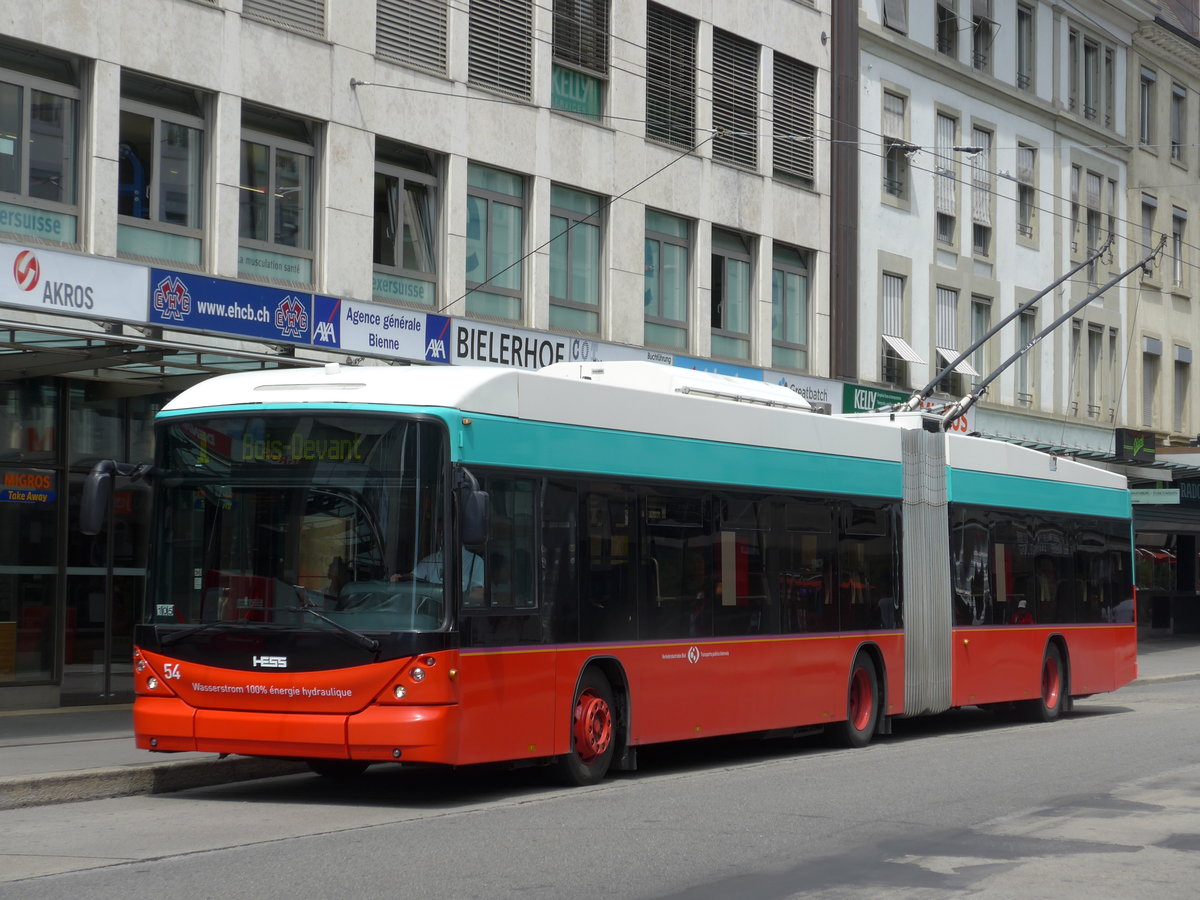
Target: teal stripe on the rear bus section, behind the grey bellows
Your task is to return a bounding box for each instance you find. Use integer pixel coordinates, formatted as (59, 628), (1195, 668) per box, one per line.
(947, 469), (1132, 518)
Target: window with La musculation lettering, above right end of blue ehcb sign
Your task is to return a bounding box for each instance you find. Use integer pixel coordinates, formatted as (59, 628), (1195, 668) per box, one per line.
(238, 104), (316, 284)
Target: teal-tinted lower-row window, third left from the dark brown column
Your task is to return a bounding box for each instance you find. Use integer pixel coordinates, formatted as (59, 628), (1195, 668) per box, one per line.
(646, 210), (691, 350)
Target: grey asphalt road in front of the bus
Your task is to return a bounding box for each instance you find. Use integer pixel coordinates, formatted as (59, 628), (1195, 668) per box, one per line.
(0, 680), (1200, 900)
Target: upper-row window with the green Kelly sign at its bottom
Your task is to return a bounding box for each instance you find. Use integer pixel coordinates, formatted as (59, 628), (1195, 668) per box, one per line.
(550, 0), (611, 119)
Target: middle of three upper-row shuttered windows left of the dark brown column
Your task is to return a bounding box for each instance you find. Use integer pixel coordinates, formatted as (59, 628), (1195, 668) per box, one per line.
(713, 29), (758, 169)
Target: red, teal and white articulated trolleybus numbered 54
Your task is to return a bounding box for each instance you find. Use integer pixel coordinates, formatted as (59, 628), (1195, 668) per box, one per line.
(88, 362), (1136, 785)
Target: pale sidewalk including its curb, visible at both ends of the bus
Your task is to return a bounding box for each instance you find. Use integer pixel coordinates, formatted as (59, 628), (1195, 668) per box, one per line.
(0, 635), (1200, 810)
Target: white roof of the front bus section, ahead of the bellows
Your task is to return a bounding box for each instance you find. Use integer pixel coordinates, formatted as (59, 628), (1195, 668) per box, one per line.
(159, 361), (900, 461)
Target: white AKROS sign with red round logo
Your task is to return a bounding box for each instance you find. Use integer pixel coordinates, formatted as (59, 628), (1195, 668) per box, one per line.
(0, 244), (149, 322)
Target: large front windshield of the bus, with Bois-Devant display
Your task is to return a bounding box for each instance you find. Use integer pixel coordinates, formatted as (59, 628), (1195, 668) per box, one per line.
(145, 412), (455, 642)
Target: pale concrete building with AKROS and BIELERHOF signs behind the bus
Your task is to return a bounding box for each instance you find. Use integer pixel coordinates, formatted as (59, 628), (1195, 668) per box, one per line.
(0, 0), (840, 708)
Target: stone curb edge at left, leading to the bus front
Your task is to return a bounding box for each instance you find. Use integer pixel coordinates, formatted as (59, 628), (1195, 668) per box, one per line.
(0, 756), (308, 810)
